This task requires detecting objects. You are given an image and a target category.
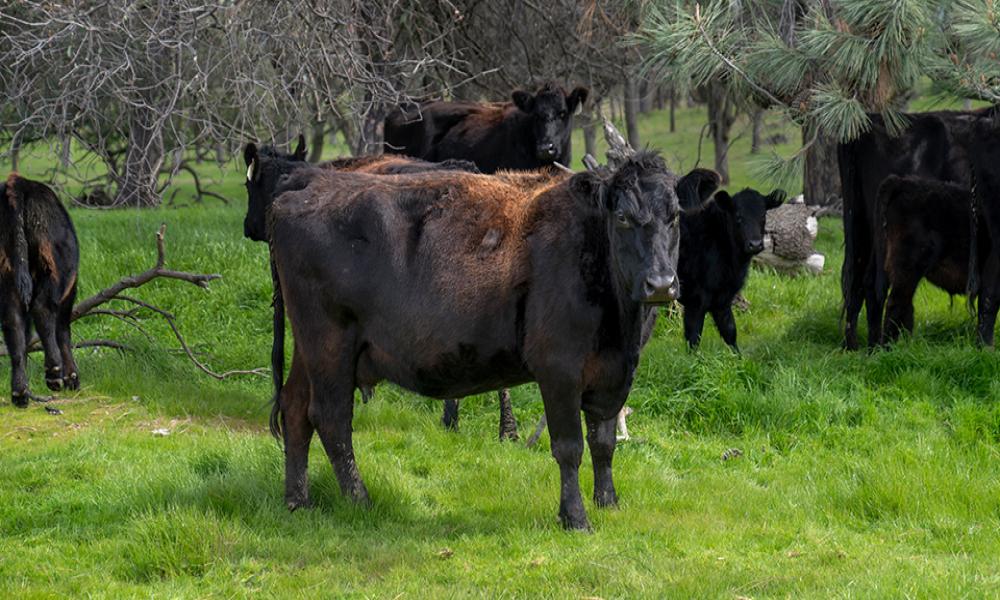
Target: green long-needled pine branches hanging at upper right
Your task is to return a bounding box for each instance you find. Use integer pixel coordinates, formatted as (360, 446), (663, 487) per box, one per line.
(633, 0), (1000, 203)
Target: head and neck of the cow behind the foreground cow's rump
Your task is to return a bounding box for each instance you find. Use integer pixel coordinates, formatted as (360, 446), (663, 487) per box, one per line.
(243, 135), (306, 242)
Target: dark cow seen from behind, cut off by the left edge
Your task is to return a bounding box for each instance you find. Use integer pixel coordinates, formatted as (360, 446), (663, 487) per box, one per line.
(0, 173), (80, 407)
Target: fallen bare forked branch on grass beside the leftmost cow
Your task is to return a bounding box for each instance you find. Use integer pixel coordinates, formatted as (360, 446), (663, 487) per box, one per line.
(0, 224), (268, 379)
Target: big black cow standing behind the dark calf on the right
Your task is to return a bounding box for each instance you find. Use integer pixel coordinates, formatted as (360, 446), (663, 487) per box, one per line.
(837, 107), (1000, 350)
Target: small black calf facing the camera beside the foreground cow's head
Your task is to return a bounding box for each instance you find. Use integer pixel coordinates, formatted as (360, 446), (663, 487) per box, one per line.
(679, 189), (785, 352)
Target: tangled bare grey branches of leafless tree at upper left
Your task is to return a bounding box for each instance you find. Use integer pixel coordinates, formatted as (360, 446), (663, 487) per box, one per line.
(0, 0), (461, 206)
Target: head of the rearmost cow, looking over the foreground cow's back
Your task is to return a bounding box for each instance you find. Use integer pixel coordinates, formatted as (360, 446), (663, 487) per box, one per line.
(511, 84), (588, 163)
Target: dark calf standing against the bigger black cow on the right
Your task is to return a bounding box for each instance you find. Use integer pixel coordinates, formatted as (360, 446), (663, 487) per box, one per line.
(875, 175), (984, 342)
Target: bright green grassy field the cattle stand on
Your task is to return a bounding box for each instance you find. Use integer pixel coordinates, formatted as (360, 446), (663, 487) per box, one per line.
(0, 105), (1000, 598)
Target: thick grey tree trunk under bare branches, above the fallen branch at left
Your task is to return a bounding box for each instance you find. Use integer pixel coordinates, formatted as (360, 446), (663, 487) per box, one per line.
(115, 109), (164, 207)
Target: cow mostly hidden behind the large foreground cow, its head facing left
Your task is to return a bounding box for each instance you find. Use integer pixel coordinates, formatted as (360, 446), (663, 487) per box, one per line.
(243, 142), (540, 441)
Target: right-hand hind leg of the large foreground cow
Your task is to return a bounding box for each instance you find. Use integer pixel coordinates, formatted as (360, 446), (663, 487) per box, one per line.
(304, 324), (370, 504)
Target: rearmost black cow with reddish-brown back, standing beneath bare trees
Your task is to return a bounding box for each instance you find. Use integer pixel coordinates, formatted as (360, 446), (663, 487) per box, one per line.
(385, 83), (588, 173)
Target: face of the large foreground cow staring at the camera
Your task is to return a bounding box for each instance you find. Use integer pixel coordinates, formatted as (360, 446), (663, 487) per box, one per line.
(574, 152), (680, 304)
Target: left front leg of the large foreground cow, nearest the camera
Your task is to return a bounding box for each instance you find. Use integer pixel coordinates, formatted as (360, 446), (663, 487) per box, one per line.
(539, 381), (590, 531)
